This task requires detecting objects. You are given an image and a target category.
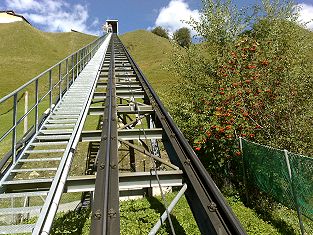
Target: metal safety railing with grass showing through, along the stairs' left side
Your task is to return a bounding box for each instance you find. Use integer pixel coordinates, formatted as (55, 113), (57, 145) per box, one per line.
(0, 36), (105, 177)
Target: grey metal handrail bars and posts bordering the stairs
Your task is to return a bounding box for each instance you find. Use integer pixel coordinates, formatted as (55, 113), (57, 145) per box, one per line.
(0, 36), (106, 171)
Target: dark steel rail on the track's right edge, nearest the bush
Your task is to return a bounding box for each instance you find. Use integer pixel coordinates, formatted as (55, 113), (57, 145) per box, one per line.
(115, 35), (246, 234)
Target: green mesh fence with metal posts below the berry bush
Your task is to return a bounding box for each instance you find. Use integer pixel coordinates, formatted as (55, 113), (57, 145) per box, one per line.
(241, 139), (313, 234)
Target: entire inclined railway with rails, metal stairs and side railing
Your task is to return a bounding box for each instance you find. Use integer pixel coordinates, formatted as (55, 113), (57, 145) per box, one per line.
(0, 30), (246, 235)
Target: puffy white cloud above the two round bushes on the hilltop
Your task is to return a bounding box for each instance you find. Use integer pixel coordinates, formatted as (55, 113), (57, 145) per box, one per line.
(149, 0), (200, 35)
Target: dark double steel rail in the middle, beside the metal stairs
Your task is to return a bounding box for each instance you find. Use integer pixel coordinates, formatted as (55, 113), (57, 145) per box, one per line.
(90, 35), (120, 235)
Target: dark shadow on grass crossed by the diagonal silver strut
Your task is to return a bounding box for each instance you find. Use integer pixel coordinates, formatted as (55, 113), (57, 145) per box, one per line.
(147, 197), (186, 235)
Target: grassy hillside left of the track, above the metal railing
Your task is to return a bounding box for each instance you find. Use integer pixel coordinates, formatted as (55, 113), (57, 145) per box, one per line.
(0, 22), (96, 97)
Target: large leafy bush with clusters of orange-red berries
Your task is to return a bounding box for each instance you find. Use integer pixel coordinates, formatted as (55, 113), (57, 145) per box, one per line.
(172, 0), (313, 186)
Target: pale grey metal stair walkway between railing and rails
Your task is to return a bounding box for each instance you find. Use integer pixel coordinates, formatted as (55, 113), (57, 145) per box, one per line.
(0, 35), (111, 234)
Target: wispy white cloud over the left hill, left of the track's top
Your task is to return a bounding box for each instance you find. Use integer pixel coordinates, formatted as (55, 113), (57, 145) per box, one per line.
(6, 0), (101, 35)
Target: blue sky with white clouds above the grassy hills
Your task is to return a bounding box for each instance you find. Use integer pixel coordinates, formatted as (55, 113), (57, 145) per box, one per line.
(0, 0), (313, 34)
